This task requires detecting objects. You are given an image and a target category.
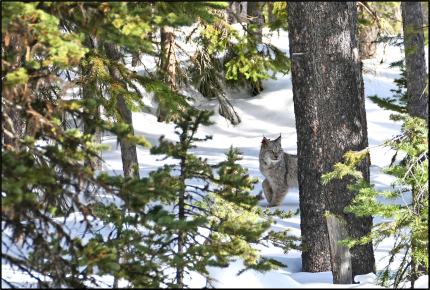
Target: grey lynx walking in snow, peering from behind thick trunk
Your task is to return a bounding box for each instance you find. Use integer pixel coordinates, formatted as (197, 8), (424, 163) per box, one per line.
(259, 136), (299, 207)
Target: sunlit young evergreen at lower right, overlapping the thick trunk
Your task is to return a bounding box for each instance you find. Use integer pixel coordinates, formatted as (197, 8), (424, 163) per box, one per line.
(322, 115), (429, 288)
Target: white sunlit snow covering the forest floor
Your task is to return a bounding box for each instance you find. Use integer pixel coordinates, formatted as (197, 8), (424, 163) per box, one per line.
(2, 26), (428, 288)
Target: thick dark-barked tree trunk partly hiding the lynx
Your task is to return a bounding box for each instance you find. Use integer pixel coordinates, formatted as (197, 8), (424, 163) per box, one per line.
(287, 2), (375, 277)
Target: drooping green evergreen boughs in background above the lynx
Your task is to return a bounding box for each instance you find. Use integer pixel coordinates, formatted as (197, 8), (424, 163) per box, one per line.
(176, 4), (291, 125)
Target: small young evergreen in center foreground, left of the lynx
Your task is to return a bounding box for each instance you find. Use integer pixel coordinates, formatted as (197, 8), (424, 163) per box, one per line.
(86, 109), (298, 287)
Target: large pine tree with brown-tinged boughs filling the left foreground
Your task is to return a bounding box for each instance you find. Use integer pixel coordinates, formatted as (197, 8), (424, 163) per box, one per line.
(2, 2), (193, 287)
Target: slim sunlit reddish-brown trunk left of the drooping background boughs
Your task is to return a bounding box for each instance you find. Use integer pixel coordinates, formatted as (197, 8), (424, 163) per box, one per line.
(157, 26), (176, 122)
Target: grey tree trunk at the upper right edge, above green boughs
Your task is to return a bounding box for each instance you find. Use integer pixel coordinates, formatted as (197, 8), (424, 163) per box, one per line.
(402, 2), (429, 125)
